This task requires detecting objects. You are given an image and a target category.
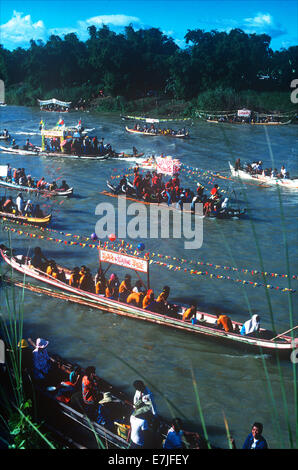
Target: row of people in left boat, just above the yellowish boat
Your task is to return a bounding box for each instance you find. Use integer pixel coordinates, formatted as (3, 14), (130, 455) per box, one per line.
(5, 163), (69, 191)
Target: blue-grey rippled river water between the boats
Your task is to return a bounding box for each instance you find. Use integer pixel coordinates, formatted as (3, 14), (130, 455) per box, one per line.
(0, 106), (298, 448)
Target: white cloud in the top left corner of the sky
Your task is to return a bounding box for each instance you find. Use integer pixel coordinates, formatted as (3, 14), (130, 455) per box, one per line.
(0, 11), (46, 46)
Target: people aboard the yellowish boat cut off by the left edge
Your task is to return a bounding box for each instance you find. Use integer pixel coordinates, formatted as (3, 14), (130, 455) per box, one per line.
(0, 193), (44, 219)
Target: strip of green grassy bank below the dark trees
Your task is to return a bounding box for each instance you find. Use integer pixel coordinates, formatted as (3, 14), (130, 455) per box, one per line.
(6, 84), (298, 119)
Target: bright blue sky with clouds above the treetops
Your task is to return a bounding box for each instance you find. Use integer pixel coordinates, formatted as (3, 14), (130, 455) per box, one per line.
(0, 0), (298, 50)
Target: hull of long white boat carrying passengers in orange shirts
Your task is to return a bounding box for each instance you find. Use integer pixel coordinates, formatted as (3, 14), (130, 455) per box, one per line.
(0, 245), (298, 358)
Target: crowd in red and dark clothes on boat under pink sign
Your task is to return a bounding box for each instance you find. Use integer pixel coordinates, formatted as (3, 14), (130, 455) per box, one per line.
(114, 165), (228, 215)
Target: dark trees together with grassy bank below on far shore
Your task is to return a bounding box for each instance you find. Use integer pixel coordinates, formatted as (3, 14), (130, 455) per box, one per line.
(0, 25), (298, 118)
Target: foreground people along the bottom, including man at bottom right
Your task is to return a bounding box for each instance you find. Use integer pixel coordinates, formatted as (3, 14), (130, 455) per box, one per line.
(11, 338), (268, 450)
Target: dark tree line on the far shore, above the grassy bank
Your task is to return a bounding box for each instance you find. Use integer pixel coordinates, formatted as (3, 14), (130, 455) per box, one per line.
(0, 25), (298, 100)
